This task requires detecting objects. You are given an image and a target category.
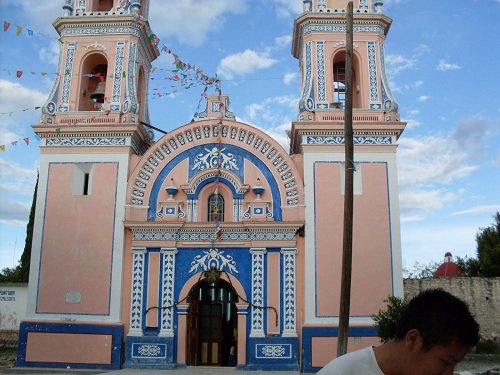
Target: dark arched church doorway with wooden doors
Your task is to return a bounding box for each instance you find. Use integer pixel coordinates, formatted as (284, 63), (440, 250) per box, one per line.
(186, 279), (238, 366)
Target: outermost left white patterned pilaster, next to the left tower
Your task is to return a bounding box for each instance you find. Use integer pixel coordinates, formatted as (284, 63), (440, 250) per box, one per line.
(128, 247), (147, 336)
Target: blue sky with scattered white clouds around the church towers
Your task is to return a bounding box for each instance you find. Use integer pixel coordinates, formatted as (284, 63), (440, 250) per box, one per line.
(0, 0), (500, 276)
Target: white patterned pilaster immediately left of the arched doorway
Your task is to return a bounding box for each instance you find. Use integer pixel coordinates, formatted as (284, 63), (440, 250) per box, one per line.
(159, 247), (177, 337)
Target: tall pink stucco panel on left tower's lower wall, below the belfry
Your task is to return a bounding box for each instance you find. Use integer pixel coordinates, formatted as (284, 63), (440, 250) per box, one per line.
(37, 163), (118, 314)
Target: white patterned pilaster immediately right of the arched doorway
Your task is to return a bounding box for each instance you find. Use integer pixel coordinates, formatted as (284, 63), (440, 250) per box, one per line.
(250, 248), (267, 337)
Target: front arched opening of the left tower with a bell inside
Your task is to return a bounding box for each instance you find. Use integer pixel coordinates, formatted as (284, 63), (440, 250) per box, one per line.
(77, 53), (108, 111)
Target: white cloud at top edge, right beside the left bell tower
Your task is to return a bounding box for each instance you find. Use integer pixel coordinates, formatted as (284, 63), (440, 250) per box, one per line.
(149, 0), (246, 46)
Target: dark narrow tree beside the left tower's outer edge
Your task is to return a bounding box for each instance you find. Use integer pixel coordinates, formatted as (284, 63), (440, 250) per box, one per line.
(0, 175), (39, 283)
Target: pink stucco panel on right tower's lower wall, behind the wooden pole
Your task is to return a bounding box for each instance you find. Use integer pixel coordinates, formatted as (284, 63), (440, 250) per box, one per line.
(315, 163), (392, 316)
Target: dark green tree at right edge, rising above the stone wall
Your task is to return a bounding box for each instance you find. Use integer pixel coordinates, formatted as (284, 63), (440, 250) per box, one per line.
(476, 211), (500, 277)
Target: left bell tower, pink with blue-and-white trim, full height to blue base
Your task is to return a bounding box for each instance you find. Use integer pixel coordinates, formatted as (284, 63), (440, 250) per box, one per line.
(18, 0), (159, 368)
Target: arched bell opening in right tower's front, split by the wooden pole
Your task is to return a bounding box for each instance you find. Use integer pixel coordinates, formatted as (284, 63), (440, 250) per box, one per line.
(333, 51), (362, 108)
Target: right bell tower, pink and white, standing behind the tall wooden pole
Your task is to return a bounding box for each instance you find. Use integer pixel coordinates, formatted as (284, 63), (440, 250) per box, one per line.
(291, 0), (406, 370)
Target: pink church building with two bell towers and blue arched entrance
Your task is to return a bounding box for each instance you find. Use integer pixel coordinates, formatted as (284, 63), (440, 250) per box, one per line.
(17, 0), (405, 372)
